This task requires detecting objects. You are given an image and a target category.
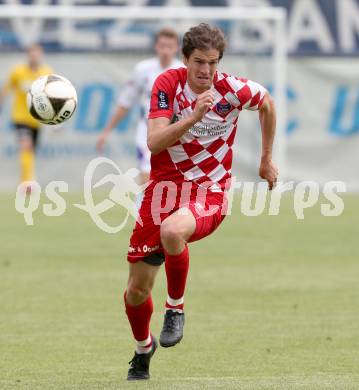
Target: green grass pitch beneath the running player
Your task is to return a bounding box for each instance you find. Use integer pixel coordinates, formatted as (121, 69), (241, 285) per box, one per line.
(0, 195), (359, 390)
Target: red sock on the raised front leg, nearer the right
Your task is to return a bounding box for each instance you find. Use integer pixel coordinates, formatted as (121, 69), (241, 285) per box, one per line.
(165, 245), (189, 312)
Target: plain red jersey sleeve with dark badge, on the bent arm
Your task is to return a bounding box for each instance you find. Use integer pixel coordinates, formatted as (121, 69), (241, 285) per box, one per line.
(148, 71), (176, 119)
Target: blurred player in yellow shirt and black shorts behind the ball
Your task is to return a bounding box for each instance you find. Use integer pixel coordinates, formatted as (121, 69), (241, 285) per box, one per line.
(0, 44), (52, 187)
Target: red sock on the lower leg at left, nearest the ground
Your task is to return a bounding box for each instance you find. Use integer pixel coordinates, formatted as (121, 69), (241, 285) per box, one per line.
(124, 292), (153, 347)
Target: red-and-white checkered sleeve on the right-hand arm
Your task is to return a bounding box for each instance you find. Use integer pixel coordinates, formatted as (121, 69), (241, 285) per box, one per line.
(236, 78), (267, 111)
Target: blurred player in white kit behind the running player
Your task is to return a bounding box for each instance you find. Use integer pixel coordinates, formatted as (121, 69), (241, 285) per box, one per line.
(97, 28), (183, 183)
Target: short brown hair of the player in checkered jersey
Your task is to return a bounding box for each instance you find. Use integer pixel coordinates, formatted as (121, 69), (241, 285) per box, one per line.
(182, 23), (227, 59)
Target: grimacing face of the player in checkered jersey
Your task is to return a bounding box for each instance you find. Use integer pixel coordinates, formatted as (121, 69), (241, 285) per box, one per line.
(183, 49), (219, 93)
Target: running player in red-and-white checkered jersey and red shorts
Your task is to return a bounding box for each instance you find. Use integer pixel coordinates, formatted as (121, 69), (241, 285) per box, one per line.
(124, 23), (278, 380)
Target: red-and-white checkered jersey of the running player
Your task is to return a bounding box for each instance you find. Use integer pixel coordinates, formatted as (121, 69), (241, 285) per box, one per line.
(149, 68), (266, 192)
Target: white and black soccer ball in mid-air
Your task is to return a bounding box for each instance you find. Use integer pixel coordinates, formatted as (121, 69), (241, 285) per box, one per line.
(27, 74), (77, 125)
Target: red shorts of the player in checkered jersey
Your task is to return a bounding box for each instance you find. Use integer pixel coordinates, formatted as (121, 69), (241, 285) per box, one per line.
(127, 182), (227, 263)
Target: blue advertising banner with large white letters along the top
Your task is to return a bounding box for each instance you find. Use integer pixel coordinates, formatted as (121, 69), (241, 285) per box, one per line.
(0, 0), (359, 56)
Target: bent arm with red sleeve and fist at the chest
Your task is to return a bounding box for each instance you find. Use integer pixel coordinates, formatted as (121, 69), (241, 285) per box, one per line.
(147, 75), (214, 154)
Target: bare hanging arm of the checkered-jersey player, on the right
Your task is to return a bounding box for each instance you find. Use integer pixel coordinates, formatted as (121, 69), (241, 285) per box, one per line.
(259, 92), (278, 190)
